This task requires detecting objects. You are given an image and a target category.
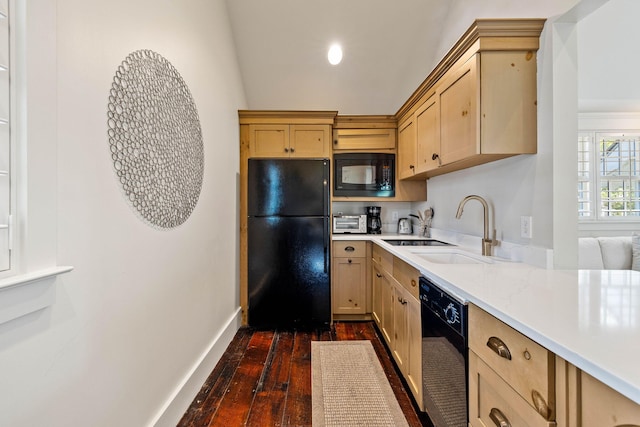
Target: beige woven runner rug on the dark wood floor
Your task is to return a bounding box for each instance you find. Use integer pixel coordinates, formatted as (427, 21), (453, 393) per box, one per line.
(311, 341), (408, 427)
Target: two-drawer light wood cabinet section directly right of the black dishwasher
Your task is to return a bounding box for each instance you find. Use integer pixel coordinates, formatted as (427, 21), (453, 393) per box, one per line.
(468, 304), (556, 427)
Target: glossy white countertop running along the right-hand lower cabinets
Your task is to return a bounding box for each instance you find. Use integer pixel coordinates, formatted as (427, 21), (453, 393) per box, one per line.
(333, 234), (640, 404)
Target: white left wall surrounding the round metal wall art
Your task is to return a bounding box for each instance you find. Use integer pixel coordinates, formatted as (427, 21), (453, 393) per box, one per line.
(0, 0), (245, 426)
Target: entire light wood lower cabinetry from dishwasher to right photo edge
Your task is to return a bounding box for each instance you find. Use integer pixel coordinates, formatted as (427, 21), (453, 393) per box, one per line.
(468, 304), (640, 427)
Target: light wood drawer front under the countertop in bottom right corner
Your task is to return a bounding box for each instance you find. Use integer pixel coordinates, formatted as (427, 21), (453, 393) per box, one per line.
(581, 372), (640, 427)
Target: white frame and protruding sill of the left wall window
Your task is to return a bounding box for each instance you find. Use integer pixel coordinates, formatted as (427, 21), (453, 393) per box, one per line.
(0, 0), (73, 327)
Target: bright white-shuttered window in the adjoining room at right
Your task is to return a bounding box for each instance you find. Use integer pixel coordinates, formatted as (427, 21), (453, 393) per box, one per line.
(578, 131), (640, 221)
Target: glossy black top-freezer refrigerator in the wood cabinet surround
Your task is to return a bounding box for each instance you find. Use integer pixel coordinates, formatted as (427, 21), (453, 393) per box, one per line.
(247, 159), (331, 329)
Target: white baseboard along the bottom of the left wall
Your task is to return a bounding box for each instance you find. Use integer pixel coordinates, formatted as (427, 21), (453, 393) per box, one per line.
(149, 307), (242, 427)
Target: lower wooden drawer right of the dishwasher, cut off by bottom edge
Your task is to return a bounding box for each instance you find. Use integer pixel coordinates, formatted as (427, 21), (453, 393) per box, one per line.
(469, 351), (556, 427)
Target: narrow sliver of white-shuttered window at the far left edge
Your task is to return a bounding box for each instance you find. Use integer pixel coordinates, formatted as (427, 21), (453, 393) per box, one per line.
(0, 0), (12, 271)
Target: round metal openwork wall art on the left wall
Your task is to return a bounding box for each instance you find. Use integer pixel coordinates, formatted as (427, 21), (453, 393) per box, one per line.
(107, 50), (204, 228)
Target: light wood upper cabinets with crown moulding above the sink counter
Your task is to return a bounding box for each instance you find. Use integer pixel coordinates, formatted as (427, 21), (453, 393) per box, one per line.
(396, 19), (544, 179)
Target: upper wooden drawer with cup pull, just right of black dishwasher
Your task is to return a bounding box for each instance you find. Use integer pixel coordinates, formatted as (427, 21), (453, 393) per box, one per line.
(469, 304), (555, 419)
